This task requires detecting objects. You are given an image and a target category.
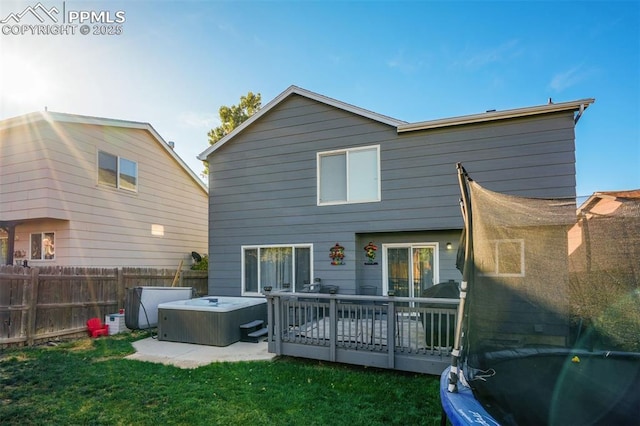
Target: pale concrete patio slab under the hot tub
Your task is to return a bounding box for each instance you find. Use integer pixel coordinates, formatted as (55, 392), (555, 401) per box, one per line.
(126, 337), (276, 368)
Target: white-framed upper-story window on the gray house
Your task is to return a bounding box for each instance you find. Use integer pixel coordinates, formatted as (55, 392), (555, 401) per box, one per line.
(318, 146), (380, 205)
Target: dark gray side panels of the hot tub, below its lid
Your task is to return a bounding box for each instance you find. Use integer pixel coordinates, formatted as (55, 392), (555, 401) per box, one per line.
(158, 303), (267, 346)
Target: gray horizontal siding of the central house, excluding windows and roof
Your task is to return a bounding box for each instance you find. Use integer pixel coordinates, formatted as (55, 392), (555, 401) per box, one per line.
(208, 95), (575, 295)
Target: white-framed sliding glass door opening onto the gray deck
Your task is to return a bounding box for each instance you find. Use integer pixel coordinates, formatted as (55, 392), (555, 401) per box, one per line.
(382, 243), (440, 297)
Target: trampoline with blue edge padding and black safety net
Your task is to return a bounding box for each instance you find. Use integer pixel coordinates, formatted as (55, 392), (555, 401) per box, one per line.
(440, 165), (640, 426)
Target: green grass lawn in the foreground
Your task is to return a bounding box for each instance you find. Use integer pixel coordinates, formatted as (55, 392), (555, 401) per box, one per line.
(0, 333), (440, 426)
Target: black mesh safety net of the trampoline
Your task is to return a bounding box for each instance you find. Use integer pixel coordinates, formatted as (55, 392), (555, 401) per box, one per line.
(466, 181), (640, 353)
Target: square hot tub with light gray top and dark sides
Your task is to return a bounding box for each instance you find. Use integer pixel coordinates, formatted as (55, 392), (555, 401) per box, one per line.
(158, 296), (267, 346)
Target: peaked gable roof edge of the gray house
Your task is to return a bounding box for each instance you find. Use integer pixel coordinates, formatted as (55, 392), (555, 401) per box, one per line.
(198, 86), (406, 161)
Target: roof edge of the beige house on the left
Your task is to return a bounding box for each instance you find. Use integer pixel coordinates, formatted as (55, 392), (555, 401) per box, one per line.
(0, 111), (208, 192)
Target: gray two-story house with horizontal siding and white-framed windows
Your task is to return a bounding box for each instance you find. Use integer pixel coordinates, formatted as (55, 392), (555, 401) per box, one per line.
(199, 86), (594, 297)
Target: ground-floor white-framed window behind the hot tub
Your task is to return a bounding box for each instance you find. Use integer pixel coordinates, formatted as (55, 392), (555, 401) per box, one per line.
(242, 244), (312, 294)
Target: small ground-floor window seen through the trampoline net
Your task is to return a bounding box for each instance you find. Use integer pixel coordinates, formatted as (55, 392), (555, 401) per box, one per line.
(480, 239), (524, 277)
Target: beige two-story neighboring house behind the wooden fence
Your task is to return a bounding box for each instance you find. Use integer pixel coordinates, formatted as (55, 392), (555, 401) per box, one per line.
(0, 112), (208, 268)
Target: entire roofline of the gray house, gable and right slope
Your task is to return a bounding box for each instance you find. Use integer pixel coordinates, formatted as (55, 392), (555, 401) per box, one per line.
(198, 86), (595, 161)
